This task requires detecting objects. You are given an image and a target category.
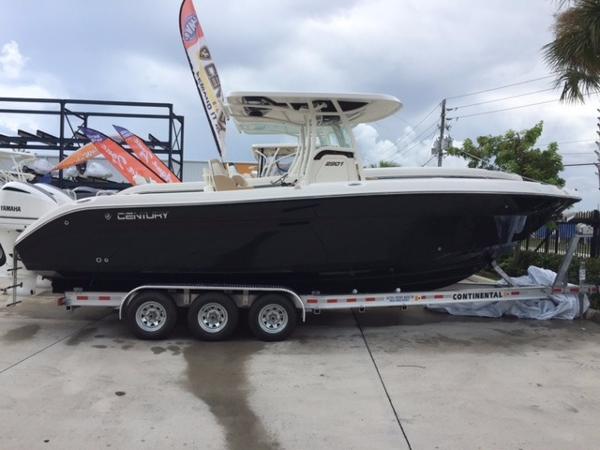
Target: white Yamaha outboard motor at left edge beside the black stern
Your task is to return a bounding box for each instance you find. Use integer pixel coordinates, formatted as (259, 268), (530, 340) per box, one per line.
(0, 181), (73, 295)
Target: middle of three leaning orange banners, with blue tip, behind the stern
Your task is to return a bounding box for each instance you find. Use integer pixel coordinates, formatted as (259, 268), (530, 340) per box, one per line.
(81, 128), (164, 185)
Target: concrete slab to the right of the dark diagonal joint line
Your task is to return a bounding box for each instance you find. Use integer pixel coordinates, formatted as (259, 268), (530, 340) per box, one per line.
(362, 310), (600, 449)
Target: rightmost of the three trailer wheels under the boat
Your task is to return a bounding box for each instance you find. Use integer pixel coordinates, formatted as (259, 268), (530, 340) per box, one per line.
(248, 294), (298, 341)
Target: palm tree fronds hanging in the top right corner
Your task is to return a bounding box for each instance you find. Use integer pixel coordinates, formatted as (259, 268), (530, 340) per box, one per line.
(544, 0), (600, 102)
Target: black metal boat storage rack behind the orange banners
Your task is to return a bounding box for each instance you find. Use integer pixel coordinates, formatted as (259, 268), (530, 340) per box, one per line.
(0, 97), (184, 180)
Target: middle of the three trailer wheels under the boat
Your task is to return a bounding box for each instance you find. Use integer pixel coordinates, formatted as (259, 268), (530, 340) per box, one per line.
(188, 292), (239, 341)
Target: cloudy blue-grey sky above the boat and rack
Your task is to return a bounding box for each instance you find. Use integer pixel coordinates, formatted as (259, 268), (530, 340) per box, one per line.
(0, 0), (600, 209)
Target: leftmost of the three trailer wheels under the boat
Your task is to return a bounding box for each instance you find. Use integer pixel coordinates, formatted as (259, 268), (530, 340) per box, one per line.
(127, 292), (177, 339)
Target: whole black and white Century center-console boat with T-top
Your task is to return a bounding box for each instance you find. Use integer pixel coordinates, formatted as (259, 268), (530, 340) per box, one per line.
(16, 93), (579, 293)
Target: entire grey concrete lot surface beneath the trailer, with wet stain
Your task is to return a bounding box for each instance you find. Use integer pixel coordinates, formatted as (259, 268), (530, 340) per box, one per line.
(0, 297), (600, 450)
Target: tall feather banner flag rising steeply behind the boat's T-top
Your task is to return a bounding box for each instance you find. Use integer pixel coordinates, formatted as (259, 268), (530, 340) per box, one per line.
(179, 0), (227, 159)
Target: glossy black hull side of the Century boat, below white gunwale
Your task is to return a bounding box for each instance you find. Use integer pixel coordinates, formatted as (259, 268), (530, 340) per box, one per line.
(17, 193), (574, 293)
